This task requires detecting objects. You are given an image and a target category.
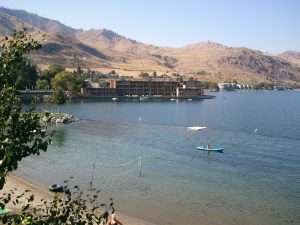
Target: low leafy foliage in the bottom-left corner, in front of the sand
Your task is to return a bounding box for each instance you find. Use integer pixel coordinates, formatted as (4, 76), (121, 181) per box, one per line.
(0, 180), (114, 225)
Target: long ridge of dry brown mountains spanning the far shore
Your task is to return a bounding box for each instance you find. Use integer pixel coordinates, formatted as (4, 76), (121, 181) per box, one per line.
(0, 7), (300, 83)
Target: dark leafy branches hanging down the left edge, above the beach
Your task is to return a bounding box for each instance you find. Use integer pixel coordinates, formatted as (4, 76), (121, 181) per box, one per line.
(0, 29), (49, 190)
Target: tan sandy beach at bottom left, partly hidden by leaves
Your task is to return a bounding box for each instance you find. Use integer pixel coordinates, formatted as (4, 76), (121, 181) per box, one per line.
(0, 173), (155, 225)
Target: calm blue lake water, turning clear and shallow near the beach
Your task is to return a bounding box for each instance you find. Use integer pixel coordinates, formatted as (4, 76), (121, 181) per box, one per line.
(17, 91), (300, 225)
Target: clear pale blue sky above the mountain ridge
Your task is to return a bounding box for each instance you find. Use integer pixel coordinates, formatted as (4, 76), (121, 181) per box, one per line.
(0, 0), (300, 53)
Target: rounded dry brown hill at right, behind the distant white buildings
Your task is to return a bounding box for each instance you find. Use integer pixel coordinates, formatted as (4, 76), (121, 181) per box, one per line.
(161, 42), (300, 82)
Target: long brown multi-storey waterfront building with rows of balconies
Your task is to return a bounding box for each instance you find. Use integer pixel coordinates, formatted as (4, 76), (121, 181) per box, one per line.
(81, 79), (203, 98)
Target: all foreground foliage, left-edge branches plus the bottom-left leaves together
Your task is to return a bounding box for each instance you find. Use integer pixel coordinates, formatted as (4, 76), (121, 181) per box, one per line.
(0, 30), (114, 225)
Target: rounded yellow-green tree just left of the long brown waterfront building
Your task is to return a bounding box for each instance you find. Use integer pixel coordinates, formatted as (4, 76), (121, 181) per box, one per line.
(51, 71), (86, 95)
